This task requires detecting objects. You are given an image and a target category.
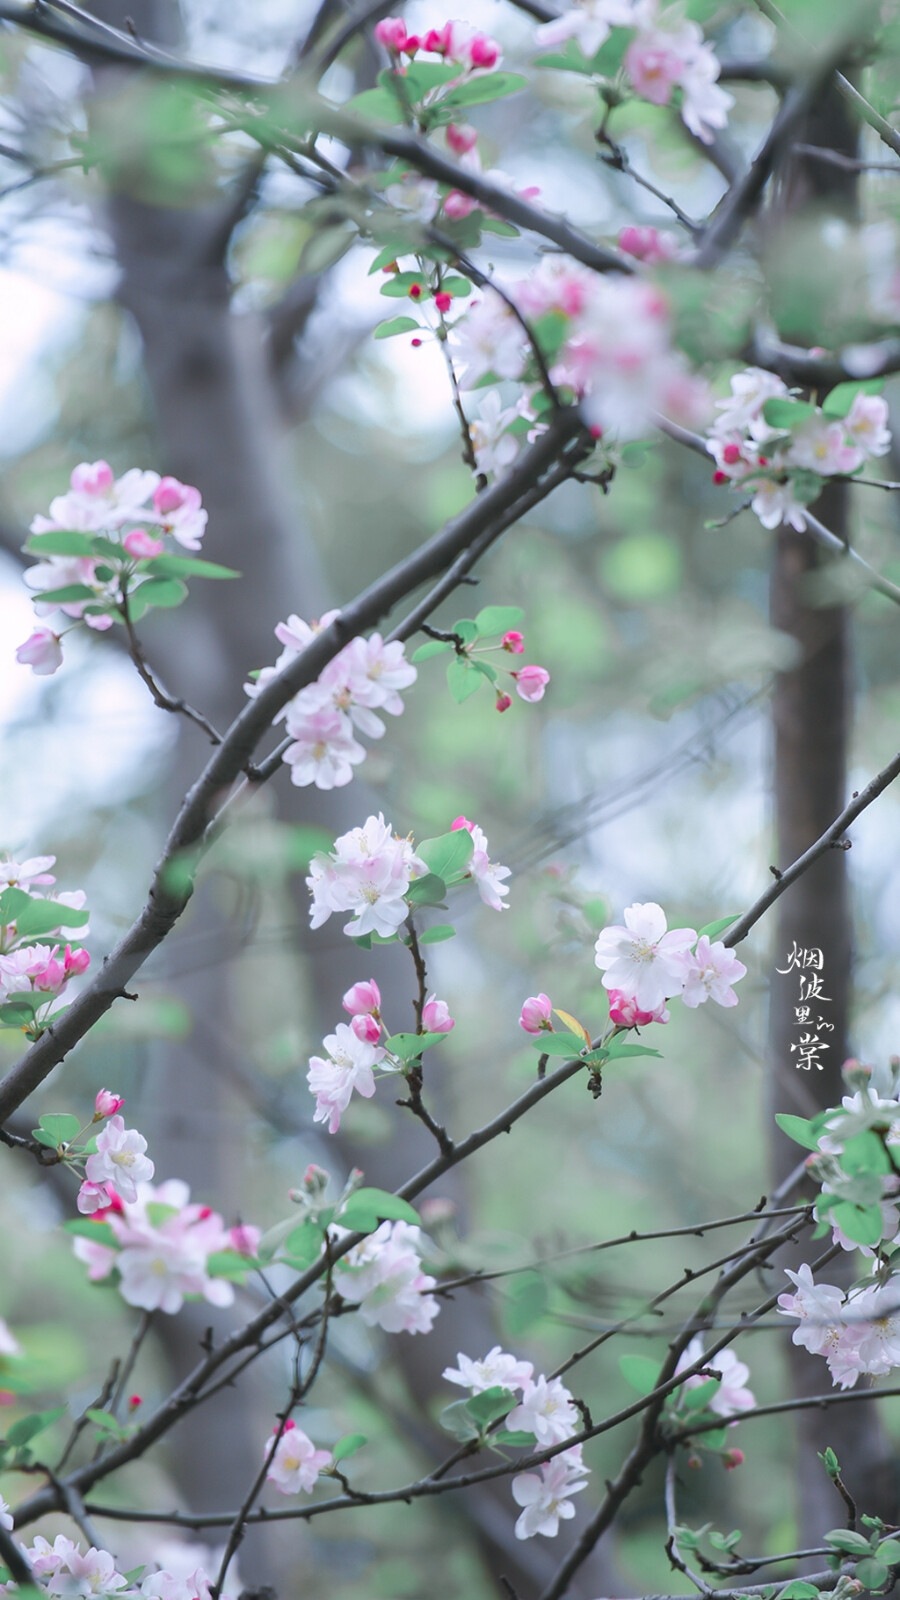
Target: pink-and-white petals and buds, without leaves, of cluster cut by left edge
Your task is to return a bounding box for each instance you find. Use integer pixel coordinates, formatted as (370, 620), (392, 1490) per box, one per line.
(0, 856), (91, 1027)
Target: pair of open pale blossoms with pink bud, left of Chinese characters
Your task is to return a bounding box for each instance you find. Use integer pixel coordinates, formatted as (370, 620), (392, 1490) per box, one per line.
(594, 901), (746, 1027)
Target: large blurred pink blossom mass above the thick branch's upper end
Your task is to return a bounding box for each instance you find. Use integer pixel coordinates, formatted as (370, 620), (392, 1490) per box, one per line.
(452, 258), (706, 460)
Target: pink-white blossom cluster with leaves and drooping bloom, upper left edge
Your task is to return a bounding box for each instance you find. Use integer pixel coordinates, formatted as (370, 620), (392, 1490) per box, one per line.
(16, 461), (211, 677)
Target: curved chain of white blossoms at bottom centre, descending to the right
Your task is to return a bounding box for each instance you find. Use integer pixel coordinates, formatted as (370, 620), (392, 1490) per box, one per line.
(444, 1344), (588, 1539)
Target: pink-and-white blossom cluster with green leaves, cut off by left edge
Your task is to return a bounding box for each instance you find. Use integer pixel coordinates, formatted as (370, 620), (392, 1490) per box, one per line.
(0, 856), (91, 1038)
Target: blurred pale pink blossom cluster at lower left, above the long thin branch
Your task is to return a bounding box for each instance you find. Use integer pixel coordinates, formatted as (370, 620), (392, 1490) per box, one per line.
(72, 1178), (258, 1314)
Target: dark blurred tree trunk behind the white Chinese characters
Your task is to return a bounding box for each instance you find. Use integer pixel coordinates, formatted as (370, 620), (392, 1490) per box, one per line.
(769, 90), (895, 1546)
